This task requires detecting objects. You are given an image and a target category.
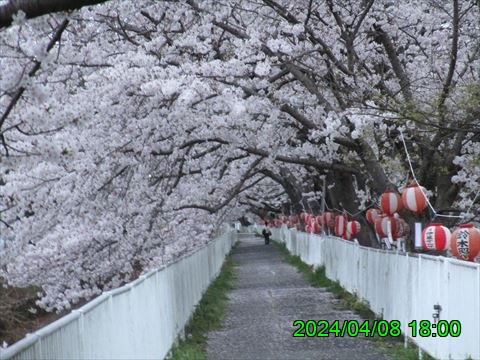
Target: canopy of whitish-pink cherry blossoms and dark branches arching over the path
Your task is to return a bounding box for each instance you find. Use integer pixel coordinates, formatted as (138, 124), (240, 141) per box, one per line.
(0, 0), (480, 310)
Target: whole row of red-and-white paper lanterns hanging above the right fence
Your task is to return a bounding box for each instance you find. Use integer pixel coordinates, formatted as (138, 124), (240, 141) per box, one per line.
(265, 183), (480, 261)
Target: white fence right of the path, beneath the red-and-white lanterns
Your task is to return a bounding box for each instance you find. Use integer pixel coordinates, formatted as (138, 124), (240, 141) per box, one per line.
(272, 227), (480, 359)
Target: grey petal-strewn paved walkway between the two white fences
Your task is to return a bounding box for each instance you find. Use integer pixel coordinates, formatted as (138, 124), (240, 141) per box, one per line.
(207, 236), (387, 360)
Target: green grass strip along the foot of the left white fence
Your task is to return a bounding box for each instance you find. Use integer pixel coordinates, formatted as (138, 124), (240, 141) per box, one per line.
(167, 249), (235, 360)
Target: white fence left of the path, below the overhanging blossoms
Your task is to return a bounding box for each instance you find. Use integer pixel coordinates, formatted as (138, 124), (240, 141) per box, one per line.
(0, 230), (237, 359)
